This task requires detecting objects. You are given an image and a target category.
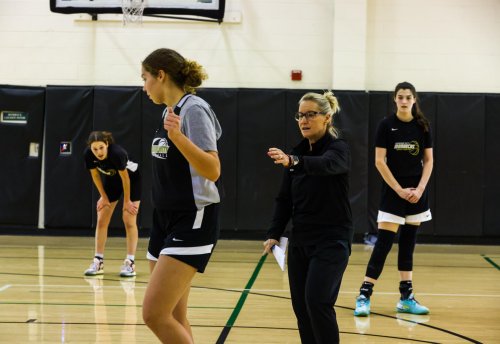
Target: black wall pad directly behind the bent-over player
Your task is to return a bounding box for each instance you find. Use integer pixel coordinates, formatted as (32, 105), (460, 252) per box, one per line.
(92, 86), (143, 228)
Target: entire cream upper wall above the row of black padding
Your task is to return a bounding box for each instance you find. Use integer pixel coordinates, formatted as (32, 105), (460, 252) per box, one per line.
(0, 0), (500, 93)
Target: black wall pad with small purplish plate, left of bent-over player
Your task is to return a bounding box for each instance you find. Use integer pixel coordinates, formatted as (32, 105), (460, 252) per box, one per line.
(45, 86), (95, 230)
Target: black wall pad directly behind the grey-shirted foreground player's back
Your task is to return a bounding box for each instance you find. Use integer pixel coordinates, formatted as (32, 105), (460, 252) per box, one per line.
(197, 88), (238, 230)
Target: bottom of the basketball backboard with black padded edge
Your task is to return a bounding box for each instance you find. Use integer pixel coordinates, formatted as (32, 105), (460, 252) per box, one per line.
(50, 0), (225, 23)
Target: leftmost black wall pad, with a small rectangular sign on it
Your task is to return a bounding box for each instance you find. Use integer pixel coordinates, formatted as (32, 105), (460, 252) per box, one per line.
(0, 86), (45, 226)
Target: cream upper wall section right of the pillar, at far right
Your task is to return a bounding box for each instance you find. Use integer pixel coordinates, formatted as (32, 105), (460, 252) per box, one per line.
(367, 0), (500, 93)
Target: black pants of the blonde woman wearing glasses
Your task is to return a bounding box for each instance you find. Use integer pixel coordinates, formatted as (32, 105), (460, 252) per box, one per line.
(288, 240), (349, 344)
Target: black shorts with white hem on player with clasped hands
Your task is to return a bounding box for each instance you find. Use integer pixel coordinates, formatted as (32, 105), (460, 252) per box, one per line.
(377, 177), (432, 225)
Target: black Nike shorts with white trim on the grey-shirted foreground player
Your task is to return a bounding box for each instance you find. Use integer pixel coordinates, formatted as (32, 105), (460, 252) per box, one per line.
(147, 203), (219, 272)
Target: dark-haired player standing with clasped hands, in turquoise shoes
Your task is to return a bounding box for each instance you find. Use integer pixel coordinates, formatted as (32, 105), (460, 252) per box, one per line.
(354, 82), (433, 316)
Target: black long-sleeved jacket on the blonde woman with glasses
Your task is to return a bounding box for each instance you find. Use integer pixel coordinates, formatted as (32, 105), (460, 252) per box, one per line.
(268, 133), (353, 246)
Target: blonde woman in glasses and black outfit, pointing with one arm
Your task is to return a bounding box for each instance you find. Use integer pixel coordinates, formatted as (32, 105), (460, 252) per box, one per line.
(264, 92), (353, 344)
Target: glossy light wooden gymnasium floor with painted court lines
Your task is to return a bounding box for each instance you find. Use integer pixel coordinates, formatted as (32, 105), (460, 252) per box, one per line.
(0, 236), (500, 344)
